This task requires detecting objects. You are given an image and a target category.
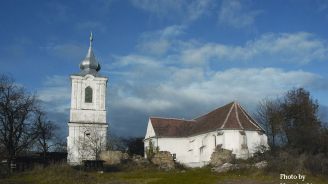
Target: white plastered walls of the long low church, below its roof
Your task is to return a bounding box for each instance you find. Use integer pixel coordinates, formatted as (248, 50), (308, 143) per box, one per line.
(144, 121), (268, 167)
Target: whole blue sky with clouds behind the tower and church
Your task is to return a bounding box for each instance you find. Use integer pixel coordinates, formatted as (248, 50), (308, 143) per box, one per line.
(0, 0), (328, 137)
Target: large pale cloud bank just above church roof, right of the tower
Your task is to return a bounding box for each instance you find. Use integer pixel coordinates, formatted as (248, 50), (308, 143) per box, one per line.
(111, 50), (323, 115)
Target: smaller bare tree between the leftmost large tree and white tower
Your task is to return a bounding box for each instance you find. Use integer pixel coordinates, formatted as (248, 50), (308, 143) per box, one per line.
(33, 110), (58, 161)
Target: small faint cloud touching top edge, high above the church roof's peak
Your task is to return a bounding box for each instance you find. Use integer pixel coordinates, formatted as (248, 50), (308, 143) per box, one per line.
(219, 0), (262, 28)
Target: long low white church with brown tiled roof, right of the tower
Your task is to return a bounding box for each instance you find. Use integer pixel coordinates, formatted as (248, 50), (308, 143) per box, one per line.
(144, 102), (268, 167)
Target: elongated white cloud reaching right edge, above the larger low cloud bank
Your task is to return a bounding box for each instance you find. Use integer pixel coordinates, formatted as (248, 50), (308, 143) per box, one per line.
(181, 32), (328, 64)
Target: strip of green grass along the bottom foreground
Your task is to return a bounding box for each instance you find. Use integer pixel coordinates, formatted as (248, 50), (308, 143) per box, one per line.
(0, 165), (328, 184)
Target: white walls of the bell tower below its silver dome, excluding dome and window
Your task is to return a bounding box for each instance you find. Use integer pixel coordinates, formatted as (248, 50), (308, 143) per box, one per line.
(67, 75), (108, 165)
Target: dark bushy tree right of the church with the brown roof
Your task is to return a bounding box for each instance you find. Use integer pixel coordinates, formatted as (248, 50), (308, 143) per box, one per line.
(255, 88), (322, 152)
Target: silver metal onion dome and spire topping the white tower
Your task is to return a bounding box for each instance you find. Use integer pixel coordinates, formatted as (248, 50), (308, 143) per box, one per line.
(80, 32), (100, 76)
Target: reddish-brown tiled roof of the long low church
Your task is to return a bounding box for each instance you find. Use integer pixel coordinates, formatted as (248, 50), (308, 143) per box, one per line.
(150, 102), (264, 137)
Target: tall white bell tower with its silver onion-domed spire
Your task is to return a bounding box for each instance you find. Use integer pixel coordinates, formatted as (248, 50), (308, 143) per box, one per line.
(67, 33), (108, 165)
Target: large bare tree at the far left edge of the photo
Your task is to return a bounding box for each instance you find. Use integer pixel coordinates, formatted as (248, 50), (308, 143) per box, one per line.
(0, 75), (36, 163)
